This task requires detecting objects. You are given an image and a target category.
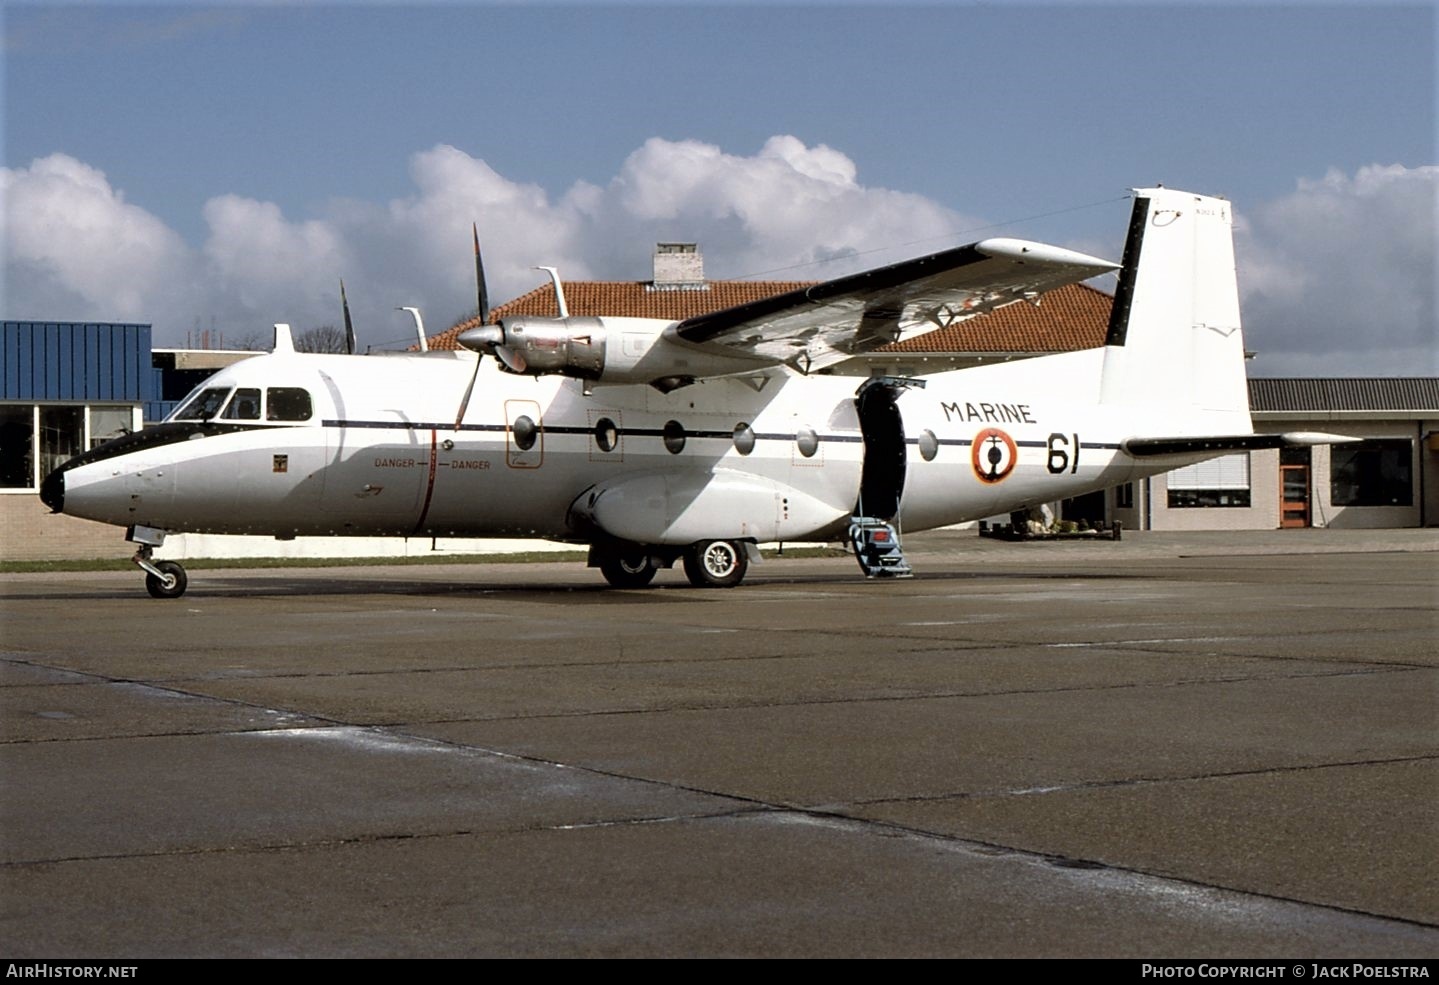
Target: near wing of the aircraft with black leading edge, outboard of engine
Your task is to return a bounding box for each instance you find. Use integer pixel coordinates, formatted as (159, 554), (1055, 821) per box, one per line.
(672, 239), (1120, 372)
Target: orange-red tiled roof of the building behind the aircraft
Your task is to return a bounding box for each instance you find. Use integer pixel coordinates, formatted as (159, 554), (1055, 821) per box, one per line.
(429, 280), (1112, 352)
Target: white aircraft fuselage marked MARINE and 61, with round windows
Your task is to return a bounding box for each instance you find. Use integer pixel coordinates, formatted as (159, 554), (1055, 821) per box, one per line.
(47, 343), (1202, 545)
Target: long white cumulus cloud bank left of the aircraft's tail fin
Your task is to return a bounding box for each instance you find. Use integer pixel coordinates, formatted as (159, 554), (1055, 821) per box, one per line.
(4, 137), (970, 345)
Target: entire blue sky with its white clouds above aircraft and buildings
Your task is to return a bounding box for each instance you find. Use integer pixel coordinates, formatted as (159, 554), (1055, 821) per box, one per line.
(3, 1), (1436, 374)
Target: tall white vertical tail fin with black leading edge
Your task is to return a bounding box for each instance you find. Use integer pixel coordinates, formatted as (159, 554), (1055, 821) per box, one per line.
(1099, 188), (1252, 431)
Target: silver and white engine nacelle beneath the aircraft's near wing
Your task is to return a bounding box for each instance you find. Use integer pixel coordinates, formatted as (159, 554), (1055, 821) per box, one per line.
(458, 315), (771, 393)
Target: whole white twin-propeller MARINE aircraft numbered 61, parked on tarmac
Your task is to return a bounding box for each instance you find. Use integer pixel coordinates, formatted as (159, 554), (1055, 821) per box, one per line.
(40, 188), (1330, 598)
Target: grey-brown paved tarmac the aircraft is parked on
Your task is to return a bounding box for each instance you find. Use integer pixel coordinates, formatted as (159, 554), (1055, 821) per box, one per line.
(0, 531), (1439, 958)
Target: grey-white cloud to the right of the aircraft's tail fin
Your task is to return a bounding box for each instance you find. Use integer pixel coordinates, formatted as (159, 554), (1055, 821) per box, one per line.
(1236, 165), (1439, 375)
